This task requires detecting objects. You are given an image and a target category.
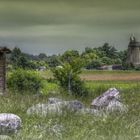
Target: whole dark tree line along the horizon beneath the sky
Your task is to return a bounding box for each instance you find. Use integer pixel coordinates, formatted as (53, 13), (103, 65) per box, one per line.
(9, 43), (127, 69)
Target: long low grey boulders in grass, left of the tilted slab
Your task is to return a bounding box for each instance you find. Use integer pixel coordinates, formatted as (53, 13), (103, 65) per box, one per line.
(27, 98), (83, 116)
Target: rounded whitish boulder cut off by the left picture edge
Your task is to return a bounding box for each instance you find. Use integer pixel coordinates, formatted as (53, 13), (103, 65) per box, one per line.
(0, 113), (21, 135)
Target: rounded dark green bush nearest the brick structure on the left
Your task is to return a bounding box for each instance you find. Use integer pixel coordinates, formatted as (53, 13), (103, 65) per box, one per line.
(7, 69), (42, 94)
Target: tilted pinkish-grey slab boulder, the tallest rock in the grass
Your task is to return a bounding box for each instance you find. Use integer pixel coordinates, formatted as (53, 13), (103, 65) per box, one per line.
(91, 88), (127, 112)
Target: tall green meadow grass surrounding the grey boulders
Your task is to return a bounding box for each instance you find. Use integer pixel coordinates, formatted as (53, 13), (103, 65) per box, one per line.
(0, 78), (140, 140)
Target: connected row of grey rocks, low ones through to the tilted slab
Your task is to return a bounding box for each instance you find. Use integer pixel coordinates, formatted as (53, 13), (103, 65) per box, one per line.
(27, 88), (127, 116)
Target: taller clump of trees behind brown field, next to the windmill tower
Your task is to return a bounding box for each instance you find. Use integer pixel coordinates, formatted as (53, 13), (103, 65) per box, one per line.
(81, 43), (127, 69)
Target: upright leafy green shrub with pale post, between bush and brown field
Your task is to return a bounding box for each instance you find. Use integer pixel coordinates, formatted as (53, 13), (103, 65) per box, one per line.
(52, 51), (88, 96)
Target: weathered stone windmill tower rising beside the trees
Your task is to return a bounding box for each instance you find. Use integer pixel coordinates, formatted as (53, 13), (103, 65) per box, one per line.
(127, 36), (140, 66)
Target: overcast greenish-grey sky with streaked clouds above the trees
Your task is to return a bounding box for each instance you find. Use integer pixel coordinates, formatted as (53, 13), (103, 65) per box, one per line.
(0, 0), (140, 55)
